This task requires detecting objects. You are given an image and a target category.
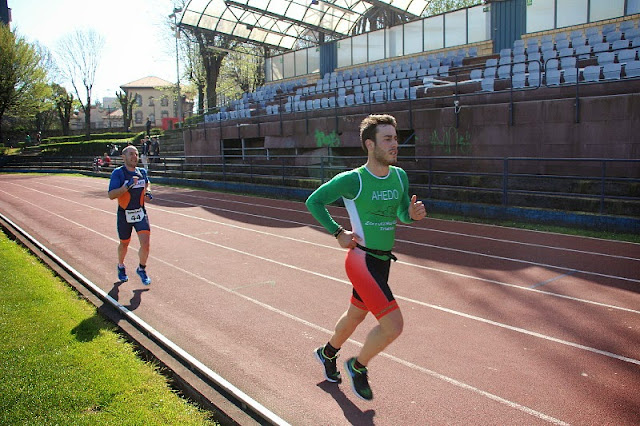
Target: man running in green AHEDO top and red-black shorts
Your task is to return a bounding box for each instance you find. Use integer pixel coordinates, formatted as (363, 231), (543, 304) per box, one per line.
(306, 115), (427, 400)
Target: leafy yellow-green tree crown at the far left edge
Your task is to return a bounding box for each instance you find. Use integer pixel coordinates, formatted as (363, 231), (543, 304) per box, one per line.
(0, 24), (49, 142)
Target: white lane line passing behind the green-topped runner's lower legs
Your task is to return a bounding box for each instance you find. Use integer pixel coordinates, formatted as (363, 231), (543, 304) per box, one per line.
(0, 185), (568, 425)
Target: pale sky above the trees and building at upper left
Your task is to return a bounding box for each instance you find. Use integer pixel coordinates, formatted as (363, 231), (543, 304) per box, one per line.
(8, 0), (176, 100)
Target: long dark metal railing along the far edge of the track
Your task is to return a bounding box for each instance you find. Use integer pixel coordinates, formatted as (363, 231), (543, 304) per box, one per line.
(0, 151), (640, 217)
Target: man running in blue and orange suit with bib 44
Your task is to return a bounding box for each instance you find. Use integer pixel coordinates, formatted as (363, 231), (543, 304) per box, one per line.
(108, 145), (152, 285)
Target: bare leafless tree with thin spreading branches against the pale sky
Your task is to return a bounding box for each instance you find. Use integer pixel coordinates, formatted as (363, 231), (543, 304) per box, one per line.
(57, 30), (104, 136)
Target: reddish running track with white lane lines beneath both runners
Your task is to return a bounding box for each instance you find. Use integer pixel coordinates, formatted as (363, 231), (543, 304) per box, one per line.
(0, 175), (640, 425)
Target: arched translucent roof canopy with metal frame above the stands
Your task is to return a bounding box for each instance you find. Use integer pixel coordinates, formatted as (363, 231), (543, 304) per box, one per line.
(179, 0), (429, 50)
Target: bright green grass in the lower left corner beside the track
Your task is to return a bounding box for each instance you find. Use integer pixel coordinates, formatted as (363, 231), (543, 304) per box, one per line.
(0, 233), (215, 425)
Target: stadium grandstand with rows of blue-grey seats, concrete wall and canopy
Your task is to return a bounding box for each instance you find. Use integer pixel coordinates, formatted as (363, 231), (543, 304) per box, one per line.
(180, 0), (640, 174)
